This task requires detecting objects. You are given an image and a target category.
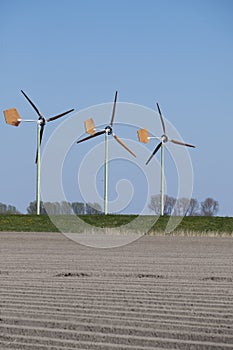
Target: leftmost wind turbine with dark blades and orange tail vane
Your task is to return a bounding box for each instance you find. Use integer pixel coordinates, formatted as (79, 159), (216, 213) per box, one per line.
(3, 90), (74, 215)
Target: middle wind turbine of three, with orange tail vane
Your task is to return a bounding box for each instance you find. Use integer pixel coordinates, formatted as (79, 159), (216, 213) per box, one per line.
(77, 91), (136, 215)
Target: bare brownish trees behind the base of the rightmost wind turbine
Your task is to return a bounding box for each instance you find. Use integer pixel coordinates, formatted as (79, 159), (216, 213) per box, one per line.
(148, 194), (219, 216)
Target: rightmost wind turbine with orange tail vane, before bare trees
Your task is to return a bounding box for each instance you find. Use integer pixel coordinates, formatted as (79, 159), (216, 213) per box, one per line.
(138, 103), (195, 216)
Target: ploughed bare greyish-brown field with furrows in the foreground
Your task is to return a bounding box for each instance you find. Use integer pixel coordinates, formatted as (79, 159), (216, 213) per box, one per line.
(0, 232), (233, 350)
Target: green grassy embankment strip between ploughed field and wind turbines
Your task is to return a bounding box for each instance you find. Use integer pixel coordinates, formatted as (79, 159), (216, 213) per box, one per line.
(0, 215), (233, 236)
